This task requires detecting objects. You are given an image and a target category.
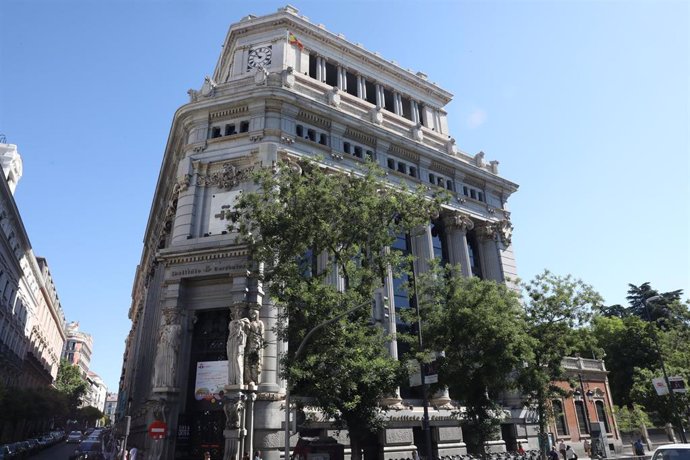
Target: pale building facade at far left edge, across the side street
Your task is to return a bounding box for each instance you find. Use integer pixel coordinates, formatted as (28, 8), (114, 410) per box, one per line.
(0, 139), (65, 387)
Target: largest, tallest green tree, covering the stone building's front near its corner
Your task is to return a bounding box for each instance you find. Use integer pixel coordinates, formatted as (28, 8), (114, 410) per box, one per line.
(232, 161), (443, 459)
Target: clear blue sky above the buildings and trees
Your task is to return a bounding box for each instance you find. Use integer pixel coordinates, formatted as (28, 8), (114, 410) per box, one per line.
(0, 0), (690, 391)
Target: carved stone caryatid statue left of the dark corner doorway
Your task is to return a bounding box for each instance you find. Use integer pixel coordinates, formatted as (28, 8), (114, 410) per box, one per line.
(152, 308), (182, 388)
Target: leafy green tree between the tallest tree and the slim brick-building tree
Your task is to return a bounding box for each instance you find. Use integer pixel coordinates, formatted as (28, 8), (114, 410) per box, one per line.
(418, 266), (532, 457)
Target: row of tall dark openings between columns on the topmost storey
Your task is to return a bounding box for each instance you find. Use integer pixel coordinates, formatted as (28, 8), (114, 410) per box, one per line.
(309, 53), (426, 126)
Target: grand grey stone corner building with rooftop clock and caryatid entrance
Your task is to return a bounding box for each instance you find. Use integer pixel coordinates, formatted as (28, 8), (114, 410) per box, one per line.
(118, 6), (524, 460)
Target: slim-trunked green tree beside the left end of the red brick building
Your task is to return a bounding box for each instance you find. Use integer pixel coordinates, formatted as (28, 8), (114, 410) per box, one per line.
(520, 270), (602, 457)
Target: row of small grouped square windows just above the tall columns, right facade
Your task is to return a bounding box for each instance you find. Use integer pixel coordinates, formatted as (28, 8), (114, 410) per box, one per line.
(295, 125), (486, 202)
